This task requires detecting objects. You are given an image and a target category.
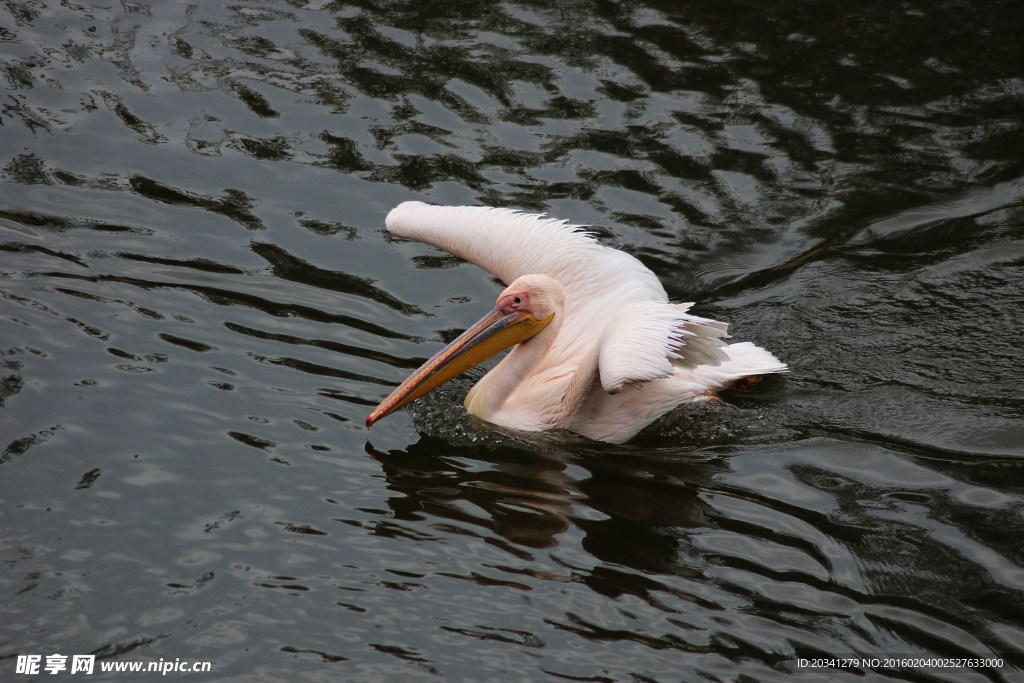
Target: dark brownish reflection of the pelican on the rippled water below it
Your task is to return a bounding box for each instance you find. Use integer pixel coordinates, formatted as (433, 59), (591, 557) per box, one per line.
(371, 437), (712, 557)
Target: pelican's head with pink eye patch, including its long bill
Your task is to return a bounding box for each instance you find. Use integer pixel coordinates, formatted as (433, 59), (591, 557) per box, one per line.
(367, 274), (563, 427)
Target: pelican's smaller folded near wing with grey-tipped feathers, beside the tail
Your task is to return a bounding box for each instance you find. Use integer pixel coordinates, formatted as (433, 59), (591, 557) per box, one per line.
(598, 301), (729, 393)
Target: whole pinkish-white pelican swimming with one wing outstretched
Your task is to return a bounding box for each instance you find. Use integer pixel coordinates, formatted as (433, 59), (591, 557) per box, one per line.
(367, 202), (786, 443)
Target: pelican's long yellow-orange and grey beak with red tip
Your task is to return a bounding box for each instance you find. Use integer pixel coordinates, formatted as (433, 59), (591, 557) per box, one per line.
(367, 308), (552, 427)
